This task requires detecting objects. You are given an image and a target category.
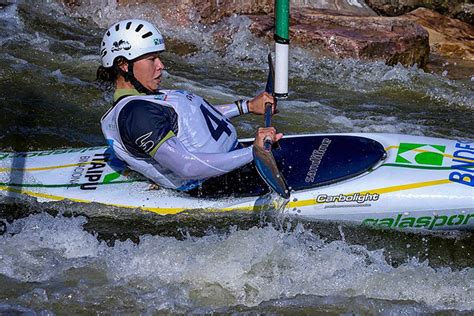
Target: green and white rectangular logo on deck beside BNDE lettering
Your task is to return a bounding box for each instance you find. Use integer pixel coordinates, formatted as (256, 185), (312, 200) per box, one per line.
(395, 143), (446, 166)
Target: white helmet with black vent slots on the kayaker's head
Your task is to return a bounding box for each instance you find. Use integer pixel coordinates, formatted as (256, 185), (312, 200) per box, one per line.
(100, 19), (165, 68)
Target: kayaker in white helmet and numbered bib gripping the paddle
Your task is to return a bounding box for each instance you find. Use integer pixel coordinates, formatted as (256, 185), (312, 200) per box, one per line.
(97, 19), (283, 191)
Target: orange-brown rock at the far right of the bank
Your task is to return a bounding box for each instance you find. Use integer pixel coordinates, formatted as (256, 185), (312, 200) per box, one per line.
(406, 8), (474, 61)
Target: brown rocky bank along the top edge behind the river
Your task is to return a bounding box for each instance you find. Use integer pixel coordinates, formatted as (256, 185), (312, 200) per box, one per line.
(63, 0), (474, 76)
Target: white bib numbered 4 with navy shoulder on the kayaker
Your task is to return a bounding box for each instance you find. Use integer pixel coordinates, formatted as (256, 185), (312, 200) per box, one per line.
(101, 90), (237, 189)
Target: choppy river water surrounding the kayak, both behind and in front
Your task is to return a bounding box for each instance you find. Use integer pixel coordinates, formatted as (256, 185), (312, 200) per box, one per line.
(0, 0), (474, 314)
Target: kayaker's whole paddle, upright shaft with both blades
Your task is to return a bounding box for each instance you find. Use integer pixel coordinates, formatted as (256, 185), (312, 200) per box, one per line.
(253, 54), (290, 199)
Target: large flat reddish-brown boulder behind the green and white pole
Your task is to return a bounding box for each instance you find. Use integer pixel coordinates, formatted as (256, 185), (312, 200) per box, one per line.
(251, 8), (429, 66)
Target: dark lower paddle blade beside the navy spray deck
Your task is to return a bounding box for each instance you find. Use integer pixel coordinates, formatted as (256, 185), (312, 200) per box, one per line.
(253, 146), (290, 199)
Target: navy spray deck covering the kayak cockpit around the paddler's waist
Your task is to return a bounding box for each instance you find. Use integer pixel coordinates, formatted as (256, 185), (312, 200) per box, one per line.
(189, 135), (386, 197)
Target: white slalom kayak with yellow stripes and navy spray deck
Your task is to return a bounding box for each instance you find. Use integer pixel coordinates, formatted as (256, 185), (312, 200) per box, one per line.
(0, 133), (474, 230)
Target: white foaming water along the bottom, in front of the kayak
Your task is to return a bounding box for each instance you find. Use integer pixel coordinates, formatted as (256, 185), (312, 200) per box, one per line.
(0, 214), (474, 311)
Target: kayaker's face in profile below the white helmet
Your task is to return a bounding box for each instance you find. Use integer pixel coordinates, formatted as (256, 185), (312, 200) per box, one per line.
(129, 53), (165, 91)
